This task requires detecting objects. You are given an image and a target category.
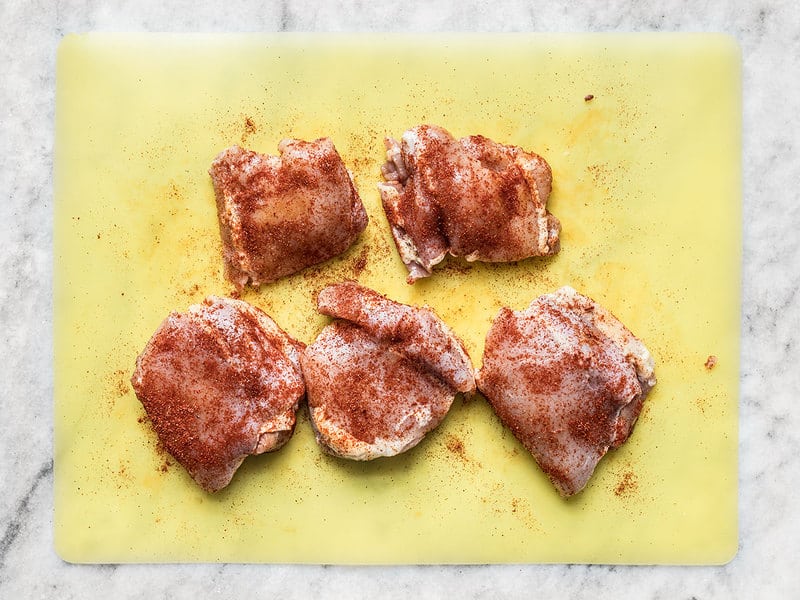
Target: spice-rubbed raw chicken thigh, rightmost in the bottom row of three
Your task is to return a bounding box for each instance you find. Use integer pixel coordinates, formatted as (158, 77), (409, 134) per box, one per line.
(477, 287), (656, 497)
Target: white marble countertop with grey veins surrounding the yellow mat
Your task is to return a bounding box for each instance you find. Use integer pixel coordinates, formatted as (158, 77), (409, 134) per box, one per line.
(0, 0), (800, 599)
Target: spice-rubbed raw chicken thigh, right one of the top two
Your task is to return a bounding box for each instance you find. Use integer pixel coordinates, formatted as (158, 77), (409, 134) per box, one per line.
(378, 125), (561, 283)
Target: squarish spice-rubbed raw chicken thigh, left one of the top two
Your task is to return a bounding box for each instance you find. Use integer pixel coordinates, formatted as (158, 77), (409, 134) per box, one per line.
(209, 138), (367, 288)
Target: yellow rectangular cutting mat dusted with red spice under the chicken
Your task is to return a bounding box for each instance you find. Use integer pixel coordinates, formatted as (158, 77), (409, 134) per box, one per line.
(54, 34), (741, 564)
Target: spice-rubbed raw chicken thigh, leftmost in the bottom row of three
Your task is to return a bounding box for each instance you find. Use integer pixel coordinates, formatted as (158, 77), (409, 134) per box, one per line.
(131, 296), (305, 492)
